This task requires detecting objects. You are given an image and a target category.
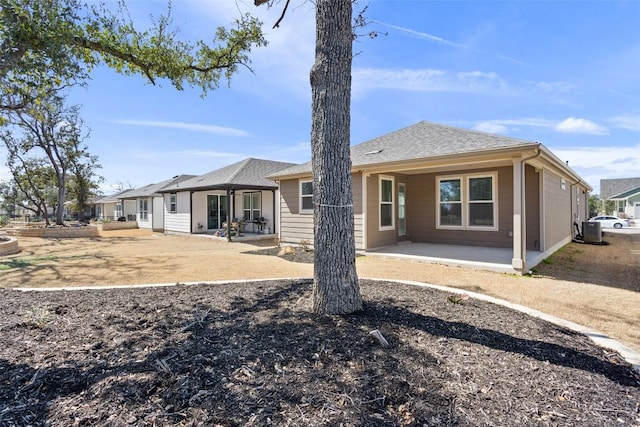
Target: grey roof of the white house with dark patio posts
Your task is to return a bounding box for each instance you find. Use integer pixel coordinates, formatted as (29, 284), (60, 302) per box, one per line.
(160, 158), (294, 193)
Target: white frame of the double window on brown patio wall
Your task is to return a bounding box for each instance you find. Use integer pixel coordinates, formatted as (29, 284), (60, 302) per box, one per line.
(436, 172), (499, 231)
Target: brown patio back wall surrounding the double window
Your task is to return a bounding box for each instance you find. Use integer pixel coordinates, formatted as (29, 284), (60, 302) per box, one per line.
(407, 166), (513, 248)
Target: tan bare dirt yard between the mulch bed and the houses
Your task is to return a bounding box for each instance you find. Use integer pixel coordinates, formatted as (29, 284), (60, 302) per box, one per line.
(0, 230), (640, 351)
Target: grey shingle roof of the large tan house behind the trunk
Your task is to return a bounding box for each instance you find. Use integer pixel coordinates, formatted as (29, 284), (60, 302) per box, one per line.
(274, 121), (538, 177)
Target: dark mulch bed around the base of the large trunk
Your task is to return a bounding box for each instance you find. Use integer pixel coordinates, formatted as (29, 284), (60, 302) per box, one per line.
(0, 281), (640, 426)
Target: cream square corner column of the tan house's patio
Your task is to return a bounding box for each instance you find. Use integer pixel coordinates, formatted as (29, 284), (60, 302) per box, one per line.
(511, 158), (527, 273)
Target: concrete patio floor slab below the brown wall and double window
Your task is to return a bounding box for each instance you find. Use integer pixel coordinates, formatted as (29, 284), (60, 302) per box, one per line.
(362, 242), (543, 274)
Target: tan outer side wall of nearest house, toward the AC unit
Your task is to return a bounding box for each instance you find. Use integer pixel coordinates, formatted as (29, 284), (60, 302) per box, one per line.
(542, 170), (575, 250)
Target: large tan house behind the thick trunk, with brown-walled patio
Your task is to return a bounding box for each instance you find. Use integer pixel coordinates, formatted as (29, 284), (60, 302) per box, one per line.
(271, 122), (591, 273)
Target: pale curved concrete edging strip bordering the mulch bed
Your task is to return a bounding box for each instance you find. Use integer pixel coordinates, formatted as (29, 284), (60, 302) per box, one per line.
(13, 277), (640, 374)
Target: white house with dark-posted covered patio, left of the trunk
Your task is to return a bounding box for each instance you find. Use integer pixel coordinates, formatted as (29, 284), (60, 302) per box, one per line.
(159, 158), (293, 239)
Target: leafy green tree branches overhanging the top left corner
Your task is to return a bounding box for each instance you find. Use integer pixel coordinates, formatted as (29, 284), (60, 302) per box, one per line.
(0, 0), (266, 109)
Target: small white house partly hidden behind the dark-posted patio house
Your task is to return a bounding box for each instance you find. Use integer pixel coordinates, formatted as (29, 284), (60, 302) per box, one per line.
(120, 175), (195, 231)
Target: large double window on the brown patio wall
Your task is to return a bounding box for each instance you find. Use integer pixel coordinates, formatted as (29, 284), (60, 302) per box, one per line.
(437, 173), (498, 230)
